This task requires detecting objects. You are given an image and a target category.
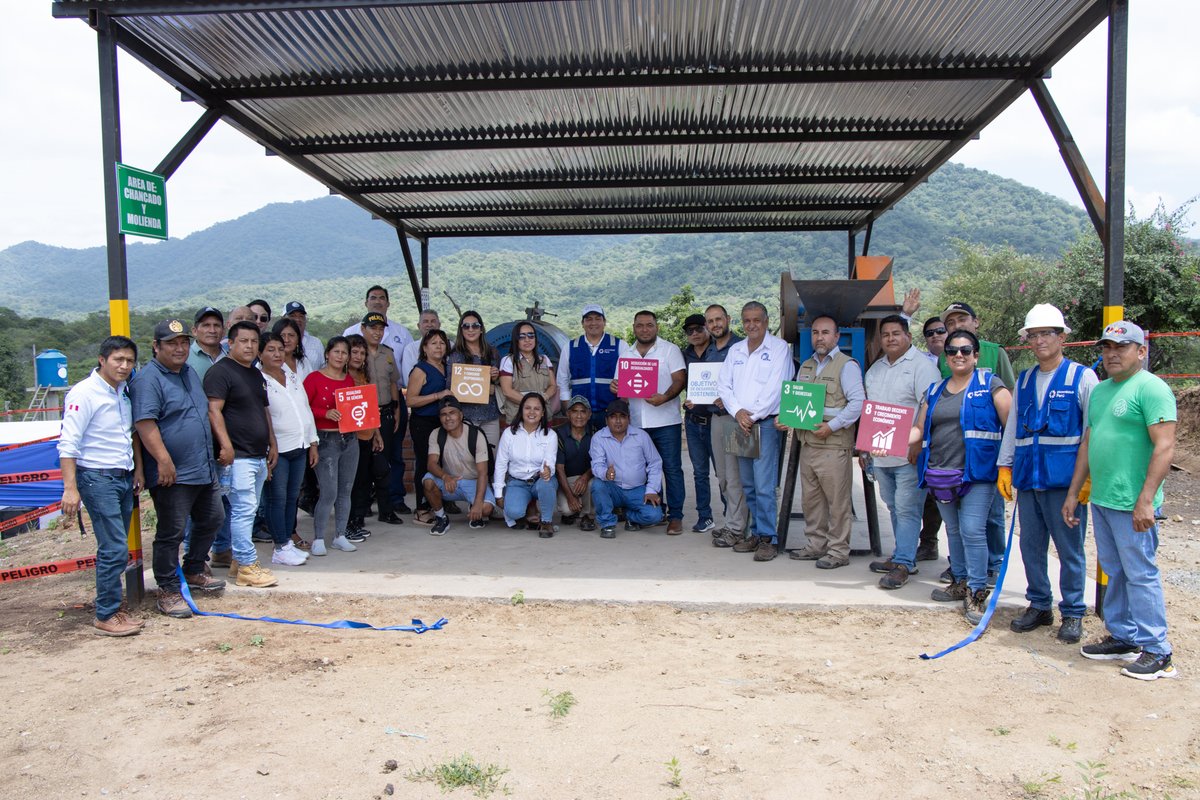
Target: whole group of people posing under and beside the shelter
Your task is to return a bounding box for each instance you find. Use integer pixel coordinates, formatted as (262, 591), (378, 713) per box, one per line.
(60, 287), (1175, 679)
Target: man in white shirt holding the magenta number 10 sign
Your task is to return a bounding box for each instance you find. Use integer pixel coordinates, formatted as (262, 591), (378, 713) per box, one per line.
(612, 311), (688, 536)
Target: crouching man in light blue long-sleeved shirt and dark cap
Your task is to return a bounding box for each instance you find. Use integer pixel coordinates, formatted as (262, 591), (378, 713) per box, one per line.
(589, 397), (662, 539)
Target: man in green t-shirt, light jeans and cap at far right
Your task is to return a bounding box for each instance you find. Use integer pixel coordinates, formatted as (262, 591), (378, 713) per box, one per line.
(1062, 320), (1178, 680)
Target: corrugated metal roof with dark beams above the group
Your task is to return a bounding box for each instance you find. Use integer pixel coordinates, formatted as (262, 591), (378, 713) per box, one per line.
(53, 0), (1108, 237)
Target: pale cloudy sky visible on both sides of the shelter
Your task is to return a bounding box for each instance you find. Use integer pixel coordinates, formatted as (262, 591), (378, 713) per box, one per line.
(0, 0), (1200, 249)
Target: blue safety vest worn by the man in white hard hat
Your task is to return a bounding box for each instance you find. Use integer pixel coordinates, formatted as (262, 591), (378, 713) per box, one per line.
(1013, 359), (1084, 491)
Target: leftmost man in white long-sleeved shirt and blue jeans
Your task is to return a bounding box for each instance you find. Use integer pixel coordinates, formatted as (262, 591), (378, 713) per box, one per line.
(58, 336), (145, 636)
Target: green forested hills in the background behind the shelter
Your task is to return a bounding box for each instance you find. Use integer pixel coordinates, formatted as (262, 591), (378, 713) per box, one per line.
(0, 164), (1087, 332)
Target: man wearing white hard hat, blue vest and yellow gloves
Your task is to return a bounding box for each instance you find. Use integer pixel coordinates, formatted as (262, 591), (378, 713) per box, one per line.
(996, 303), (1099, 644)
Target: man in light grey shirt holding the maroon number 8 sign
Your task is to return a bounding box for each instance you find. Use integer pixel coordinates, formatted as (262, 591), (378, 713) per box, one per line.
(863, 314), (941, 589)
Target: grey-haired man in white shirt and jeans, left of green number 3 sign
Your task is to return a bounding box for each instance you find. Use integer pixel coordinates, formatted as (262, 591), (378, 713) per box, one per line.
(718, 301), (794, 561)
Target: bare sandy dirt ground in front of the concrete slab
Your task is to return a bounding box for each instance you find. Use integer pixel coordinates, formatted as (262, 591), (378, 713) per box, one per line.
(0, 395), (1200, 800)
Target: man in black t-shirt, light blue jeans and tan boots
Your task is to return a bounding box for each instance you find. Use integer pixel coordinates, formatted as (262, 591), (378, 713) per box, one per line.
(204, 323), (278, 589)
